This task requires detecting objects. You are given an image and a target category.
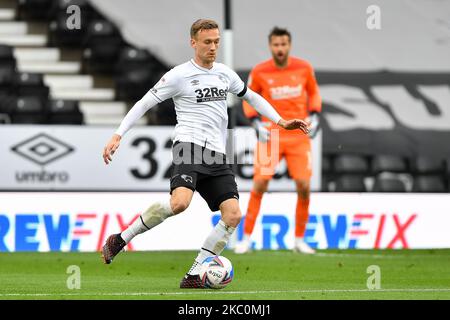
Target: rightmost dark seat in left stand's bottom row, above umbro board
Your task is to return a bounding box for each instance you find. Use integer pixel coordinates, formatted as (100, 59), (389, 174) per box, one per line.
(47, 100), (83, 124)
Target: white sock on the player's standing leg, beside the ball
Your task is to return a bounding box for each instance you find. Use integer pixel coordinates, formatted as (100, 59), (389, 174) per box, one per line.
(188, 220), (236, 275)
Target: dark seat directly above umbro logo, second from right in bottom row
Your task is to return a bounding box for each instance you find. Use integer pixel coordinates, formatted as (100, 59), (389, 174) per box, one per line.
(11, 97), (47, 124)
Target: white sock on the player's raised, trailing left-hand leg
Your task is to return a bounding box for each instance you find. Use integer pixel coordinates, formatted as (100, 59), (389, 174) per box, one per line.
(121, 201), (174, 243)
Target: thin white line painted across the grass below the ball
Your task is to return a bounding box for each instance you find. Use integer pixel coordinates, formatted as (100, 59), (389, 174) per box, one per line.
(0, 288), (450, 297)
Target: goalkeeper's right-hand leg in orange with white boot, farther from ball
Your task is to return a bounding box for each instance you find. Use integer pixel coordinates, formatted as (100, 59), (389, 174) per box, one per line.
(286, 139), (315, 254)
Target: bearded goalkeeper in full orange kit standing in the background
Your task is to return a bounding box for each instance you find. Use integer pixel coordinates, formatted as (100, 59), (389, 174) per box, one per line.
(235, 27), (321, 253)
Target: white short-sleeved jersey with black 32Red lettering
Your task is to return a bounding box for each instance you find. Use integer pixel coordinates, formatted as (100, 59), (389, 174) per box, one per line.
(149, 59), (246, 153)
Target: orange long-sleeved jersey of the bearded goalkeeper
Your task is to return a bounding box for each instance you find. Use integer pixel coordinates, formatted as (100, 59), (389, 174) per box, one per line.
(243, 57), (322, 133)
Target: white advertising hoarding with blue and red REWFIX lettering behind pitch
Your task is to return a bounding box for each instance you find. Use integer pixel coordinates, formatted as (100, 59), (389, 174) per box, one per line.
(0, 192), (450, 251)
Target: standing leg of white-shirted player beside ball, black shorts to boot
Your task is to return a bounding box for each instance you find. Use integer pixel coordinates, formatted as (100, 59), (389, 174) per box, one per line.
(180, 174), (241, 288)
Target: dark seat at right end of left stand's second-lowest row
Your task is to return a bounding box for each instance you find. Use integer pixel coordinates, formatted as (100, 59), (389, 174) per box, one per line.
(14, 73), (49, 101)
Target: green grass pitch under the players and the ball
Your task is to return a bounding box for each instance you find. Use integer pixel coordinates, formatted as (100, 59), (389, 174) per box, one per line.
(0, 250), (450, 300)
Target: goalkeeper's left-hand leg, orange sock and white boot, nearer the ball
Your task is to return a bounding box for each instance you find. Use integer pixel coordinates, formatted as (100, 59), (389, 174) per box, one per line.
(234, 139), (281, 254)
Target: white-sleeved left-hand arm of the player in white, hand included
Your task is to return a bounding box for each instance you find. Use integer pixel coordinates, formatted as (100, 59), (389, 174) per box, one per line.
(103, 69), (178, 164)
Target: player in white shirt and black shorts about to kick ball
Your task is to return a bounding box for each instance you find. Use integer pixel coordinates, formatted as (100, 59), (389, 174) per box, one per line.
(102, 19), (309, 288)
